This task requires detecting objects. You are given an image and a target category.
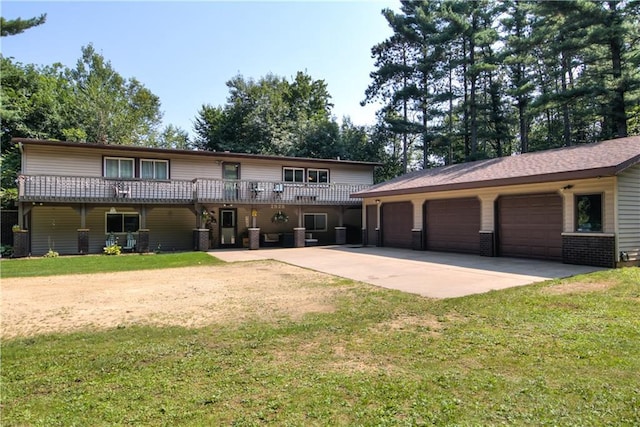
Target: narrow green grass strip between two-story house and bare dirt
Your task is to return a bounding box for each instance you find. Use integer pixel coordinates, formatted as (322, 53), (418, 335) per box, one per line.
(0, 252), (222, 279)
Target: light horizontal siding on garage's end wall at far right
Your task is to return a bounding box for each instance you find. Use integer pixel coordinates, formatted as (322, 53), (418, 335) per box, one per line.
(617, 165), (640, 261)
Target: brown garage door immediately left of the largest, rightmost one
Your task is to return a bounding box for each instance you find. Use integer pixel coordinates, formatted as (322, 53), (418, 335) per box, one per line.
(425, 197), (480, 254)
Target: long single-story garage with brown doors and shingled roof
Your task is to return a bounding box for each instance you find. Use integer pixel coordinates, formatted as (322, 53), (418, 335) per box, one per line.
(353, 136), (640, 267)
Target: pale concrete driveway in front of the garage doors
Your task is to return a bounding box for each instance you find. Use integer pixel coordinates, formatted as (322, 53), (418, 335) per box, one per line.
(209, 246), (602, 298)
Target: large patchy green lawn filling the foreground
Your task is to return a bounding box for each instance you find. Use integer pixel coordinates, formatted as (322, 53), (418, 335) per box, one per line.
(1, 268), (640, 426)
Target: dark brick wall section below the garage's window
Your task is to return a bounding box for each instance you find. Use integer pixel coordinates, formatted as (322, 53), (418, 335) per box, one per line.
(562, 234), (616, 268)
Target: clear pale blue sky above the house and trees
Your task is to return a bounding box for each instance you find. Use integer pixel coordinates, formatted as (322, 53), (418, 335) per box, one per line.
(1, 0), (399, 137)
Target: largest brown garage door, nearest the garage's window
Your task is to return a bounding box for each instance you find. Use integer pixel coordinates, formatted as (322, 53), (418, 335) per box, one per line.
(498, 194), (562, 260)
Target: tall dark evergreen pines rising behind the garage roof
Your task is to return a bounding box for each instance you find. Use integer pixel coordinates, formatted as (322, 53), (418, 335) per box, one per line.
(364, 0), (640, 170)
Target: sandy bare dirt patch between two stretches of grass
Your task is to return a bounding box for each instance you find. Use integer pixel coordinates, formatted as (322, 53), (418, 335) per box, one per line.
(1, 261), (338, 338)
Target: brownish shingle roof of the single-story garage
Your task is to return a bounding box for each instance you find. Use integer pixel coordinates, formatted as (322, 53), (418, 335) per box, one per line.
(353, 136), (640, 197)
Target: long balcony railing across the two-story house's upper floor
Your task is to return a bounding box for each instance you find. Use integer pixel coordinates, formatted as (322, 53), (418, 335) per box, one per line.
(18, 175), (369, 205)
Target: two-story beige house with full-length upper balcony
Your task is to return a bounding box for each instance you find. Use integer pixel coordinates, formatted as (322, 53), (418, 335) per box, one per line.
(14, 138), (377, 256)
